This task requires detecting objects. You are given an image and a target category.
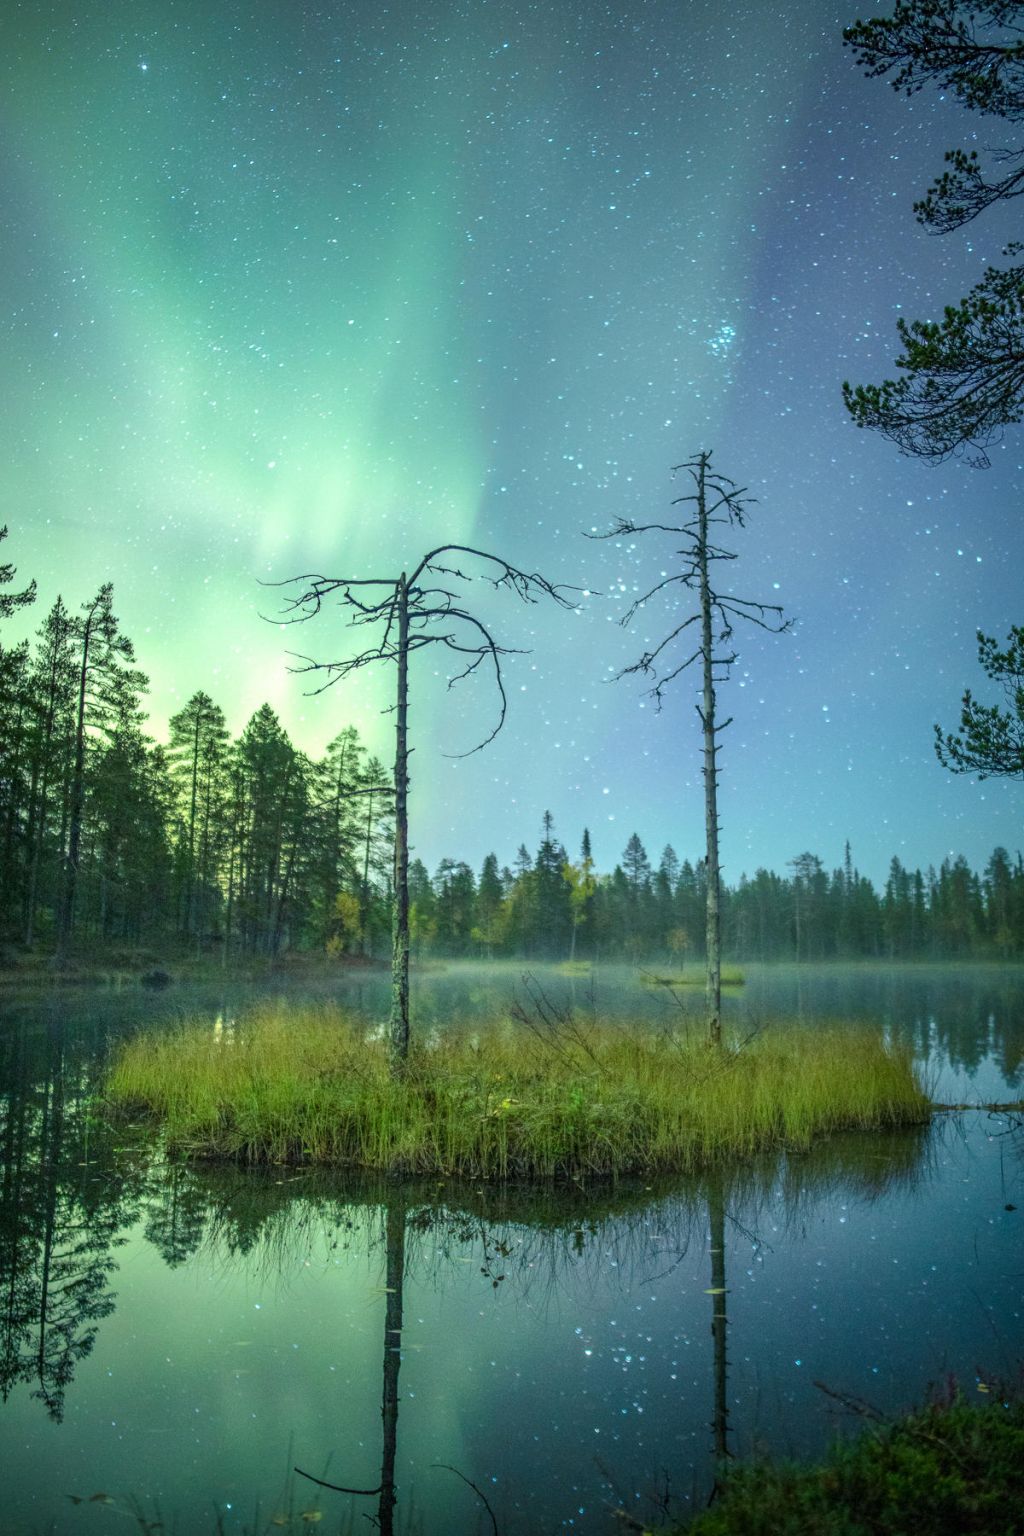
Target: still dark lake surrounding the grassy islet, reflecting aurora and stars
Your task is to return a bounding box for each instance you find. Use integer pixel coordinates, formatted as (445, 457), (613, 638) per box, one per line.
(0, 965), (1024, 1536)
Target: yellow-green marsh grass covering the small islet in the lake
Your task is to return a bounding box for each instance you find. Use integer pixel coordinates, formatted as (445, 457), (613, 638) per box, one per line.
(106, 1001), (927, 1180)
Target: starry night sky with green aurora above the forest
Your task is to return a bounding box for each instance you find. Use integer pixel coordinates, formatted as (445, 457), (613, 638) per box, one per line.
(0, 0), (1024, 882)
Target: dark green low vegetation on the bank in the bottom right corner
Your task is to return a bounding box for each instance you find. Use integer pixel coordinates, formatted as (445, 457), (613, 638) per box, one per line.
(679, 1389), (1024, 1536)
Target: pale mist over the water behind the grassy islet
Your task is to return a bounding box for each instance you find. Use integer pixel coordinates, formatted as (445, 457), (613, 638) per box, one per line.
(164, 960), (1024, 1103)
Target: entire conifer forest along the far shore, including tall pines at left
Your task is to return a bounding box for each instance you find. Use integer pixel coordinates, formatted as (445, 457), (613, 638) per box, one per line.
(0, 567), (1024, 962)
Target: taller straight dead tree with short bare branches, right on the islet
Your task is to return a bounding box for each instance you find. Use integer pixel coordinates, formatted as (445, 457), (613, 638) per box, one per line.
(590, 453), (791, 1046)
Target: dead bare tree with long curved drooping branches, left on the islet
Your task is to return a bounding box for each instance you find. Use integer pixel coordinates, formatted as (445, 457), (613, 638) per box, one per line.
(282, 544), (574, 1075)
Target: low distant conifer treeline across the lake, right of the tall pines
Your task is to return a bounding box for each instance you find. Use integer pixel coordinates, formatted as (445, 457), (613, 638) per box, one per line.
(451, 817), (1024, 962)
